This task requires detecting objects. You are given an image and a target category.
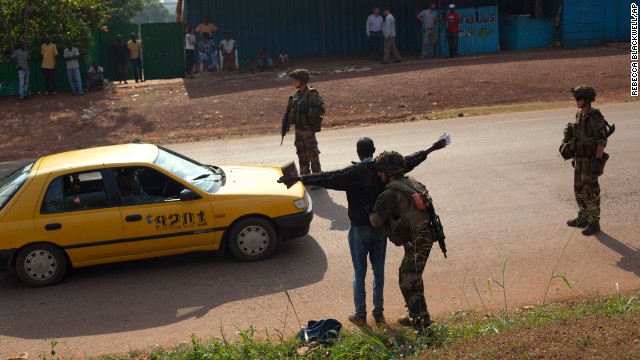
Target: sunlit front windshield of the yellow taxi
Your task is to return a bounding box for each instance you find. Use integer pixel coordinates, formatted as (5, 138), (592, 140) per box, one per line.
(154, 147), (225, 193)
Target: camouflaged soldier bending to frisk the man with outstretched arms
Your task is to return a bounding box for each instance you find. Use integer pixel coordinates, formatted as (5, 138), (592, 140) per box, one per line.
(369, 151), (435, 329)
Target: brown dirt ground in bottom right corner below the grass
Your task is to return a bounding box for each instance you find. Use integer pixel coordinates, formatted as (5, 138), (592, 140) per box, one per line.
(428, 311), (640, 359)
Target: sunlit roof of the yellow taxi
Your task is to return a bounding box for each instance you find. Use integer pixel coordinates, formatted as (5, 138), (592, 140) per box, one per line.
(38, 144), (158, 172)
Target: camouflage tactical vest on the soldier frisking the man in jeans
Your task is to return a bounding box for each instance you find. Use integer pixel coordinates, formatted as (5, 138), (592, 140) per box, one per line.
(385, 177), (431, 246)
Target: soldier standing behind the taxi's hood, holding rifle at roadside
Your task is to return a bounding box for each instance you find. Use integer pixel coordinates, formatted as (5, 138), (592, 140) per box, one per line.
(288, 69), (325, 175)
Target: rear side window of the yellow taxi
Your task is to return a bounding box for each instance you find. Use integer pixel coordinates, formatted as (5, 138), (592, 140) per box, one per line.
(40, 171), (109, 214)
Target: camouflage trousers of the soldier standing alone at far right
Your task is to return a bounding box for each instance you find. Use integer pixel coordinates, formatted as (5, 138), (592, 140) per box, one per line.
(573, 158), (600, 223)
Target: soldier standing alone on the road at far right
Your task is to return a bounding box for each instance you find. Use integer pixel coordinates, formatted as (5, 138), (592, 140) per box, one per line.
(567, 85), (608, 235)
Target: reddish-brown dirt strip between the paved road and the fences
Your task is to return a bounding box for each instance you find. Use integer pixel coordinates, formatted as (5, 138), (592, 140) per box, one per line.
(0, 44), (630, 161)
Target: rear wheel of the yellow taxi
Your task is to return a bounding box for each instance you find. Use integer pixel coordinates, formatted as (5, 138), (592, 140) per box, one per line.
(16, 244), (67, 287)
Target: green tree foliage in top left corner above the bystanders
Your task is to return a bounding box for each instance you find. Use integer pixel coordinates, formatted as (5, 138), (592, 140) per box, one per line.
(0, 0), (143, 58)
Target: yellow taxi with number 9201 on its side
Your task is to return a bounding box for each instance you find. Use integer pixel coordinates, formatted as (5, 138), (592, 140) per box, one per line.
(0, 144), (313, 286)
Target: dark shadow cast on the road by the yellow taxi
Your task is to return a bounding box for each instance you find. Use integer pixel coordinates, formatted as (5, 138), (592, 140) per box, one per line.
(0, 236), (327, 339)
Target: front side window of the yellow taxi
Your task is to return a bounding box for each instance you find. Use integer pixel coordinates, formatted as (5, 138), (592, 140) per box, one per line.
(112, 167), (184, 205)
